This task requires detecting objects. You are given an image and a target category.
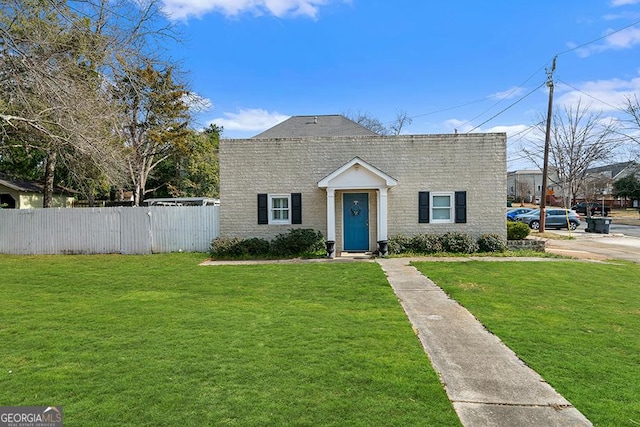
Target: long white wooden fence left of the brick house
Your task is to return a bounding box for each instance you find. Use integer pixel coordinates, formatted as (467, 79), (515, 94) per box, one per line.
(0, 206), (220, 254)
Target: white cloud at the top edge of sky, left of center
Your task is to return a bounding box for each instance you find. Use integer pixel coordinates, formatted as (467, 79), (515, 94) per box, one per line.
(162, 0), (334, 20)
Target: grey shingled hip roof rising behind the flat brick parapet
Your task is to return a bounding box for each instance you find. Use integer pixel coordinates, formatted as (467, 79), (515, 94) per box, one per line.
(253, 114), (378, 139)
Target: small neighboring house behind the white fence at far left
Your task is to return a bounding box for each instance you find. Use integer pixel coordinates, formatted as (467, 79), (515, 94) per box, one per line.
(0, 178), (74, 209)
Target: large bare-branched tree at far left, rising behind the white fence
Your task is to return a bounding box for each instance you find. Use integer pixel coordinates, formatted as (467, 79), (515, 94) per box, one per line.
(0, 0), (179, 207)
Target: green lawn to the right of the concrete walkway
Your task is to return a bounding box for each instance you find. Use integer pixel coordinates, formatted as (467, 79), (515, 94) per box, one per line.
(415, 261), (640, 427)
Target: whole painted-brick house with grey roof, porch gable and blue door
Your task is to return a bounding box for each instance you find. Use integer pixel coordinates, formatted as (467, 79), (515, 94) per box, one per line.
(220, 116), (506, 257)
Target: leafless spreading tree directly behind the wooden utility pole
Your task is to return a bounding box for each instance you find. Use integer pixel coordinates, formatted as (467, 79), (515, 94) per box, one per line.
(524, 102), (622, 205)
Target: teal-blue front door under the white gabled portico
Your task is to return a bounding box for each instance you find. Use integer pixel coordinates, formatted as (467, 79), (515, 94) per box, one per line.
(342, 193), (369, 252)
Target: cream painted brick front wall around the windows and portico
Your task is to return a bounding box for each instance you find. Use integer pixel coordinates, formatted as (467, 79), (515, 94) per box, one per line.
(220, 134), (506, 244)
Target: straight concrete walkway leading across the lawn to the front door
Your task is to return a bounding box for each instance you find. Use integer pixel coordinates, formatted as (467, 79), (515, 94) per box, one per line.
(376, 258), (592, 427)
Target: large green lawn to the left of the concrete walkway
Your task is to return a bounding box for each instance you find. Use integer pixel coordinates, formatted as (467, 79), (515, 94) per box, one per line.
(0, 254), (459, 426)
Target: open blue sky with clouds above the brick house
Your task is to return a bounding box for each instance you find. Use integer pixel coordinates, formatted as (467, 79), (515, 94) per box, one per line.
(163, 0), (640, 169)
